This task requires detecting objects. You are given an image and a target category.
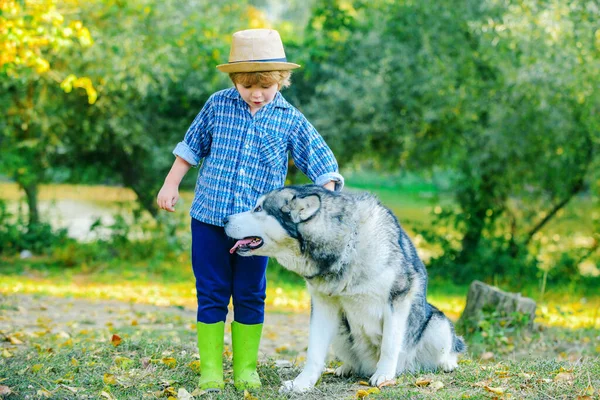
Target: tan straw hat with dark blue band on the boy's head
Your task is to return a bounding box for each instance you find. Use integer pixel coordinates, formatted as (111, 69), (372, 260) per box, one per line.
(217, 29), (300, 73)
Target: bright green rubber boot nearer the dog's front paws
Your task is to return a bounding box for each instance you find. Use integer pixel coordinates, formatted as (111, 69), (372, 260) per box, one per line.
(231, 321), (263, 390)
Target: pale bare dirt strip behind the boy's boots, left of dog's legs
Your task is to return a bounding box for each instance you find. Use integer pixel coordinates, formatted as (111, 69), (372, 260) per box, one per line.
(0, 294), (310, 361)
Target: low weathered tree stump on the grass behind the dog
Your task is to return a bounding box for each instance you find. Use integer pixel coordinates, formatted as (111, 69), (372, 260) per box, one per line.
(457, 281), (536, 329)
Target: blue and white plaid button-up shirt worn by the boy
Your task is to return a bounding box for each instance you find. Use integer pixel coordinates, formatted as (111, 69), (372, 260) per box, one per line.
(173, 88), (344, 226)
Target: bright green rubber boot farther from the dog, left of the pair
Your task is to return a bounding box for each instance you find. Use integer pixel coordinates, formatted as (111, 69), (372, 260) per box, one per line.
(196, 322), (225, 392)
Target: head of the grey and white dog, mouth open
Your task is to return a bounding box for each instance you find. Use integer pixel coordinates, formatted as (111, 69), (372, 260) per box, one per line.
(225, 185), (326, 256)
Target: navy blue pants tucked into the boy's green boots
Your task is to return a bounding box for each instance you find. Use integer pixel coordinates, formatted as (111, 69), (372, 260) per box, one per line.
(192, 218), (269, 325)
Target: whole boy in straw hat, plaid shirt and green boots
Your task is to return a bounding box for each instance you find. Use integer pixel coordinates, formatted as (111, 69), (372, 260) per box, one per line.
(157, 29), (344, 390)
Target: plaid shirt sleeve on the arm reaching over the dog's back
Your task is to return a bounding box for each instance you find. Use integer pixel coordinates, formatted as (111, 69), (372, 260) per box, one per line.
(288, 114), (344, 191)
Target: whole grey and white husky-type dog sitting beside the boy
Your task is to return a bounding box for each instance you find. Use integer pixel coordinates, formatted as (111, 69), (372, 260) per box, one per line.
(225, 185), (465, 392)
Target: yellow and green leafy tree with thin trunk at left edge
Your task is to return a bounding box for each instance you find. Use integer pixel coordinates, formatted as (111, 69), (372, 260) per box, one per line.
(0, 0), (96, 228)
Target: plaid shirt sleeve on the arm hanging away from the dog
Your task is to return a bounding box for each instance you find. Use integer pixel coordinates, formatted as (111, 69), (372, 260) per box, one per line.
(173, 97), (213, 166)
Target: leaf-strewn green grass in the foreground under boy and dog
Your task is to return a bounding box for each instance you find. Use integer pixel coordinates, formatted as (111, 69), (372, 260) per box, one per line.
(0, 300), (600, 399)
